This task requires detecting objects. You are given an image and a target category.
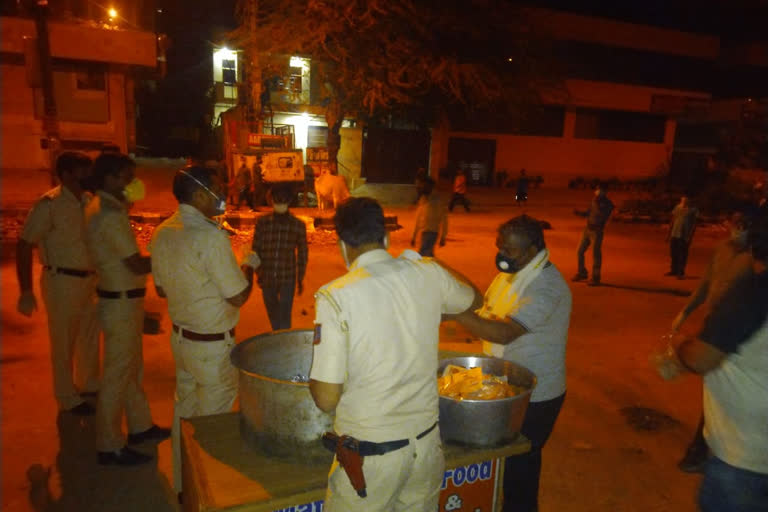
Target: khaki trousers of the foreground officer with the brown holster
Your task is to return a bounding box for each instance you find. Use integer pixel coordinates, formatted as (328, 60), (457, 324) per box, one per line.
(323, 428), (445, 512)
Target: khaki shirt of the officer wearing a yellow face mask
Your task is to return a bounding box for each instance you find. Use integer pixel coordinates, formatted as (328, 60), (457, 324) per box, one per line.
(85, 190), (147, 292)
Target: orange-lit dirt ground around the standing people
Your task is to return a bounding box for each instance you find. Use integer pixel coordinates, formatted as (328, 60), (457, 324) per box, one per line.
(0, 182), (725, 512)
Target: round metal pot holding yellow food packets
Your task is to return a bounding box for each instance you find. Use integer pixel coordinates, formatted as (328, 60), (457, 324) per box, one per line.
(438, 357), (536, 446)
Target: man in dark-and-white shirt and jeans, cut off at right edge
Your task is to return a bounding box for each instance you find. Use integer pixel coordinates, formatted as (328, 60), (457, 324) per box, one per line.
(659, 211), (768, 512)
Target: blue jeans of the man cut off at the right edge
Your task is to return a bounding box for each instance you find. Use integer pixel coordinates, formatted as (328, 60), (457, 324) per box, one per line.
(699, 456), (768, 512)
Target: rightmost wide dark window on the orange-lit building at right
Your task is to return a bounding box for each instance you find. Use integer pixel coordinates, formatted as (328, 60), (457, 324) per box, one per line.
(574, 109), (667, 143)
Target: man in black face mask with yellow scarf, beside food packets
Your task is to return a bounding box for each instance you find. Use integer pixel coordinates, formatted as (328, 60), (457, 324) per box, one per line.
(456, 215), (571, 512)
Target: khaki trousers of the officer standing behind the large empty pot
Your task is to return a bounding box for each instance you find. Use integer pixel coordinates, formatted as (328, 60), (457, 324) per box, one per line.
(171, 332), (238, 492)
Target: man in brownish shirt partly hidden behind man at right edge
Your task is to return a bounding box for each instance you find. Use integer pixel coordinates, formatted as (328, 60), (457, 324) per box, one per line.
(671, 212), (752, 473)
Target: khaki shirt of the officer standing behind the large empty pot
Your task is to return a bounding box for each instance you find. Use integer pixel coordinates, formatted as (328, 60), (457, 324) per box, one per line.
(149, 204), (248, 334)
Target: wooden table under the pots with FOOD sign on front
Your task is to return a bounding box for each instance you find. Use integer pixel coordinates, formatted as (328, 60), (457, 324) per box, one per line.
(181, 413), (530, 512)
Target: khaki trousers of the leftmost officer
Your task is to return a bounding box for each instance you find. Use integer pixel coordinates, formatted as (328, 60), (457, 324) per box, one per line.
(40, 269), (99, 410)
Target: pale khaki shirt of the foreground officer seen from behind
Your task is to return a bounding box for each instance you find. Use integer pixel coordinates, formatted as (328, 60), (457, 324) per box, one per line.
(310, 249), (474, 442)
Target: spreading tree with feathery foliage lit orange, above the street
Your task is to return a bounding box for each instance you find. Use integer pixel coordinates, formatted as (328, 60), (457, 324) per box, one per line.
(234, 0), (555, 172)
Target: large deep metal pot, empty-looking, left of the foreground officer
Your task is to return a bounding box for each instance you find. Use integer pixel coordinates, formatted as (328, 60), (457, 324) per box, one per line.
(230, 329), (333, 462)
